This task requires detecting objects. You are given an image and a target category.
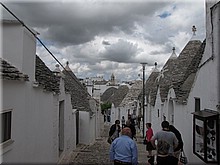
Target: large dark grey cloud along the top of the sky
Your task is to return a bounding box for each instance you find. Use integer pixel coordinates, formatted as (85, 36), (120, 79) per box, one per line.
(3, 1), (171, 45)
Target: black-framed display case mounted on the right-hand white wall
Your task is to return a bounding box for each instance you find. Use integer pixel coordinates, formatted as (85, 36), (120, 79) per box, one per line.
(192, 109), (219, 163)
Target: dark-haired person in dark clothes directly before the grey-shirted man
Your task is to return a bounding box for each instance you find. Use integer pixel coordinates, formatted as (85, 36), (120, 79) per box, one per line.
(147, 140), (180, 165)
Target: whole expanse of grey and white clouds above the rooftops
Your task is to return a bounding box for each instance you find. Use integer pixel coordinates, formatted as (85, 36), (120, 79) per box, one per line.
(3, 0), (205, 81)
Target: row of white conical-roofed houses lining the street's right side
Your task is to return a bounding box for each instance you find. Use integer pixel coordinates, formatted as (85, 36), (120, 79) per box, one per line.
(146, 0), (220, 164)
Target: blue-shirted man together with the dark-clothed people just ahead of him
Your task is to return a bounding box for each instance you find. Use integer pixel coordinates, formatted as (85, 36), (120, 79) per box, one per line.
(109, 117), (138, 165)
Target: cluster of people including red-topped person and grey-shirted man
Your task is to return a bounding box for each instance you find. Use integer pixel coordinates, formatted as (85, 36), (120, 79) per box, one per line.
(146, 121), (183, 165)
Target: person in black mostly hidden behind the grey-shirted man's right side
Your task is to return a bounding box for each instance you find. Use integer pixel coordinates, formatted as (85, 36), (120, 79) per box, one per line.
(169, 125), (183, 158)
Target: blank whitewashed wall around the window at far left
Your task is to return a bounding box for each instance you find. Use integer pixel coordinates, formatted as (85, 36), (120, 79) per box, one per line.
(2, 82), (58, 163)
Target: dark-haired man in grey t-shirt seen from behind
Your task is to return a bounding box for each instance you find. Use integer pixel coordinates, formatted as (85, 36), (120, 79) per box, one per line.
(151, 121), (178, 155)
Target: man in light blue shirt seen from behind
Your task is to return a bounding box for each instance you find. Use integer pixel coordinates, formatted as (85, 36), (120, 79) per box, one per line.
(109, 127), (138, 165)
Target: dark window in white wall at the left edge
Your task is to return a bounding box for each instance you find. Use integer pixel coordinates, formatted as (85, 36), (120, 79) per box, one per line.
(1, 111), (12, 143)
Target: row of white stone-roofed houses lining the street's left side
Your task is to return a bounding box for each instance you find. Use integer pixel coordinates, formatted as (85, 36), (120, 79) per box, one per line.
(0, 21), (100, 163)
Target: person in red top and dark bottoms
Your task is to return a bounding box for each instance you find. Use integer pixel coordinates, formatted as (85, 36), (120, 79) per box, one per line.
(145, 123), (155, 157)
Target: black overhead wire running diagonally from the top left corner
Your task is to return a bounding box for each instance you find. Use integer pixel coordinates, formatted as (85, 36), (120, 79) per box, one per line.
(0, 2), (87, 90)
